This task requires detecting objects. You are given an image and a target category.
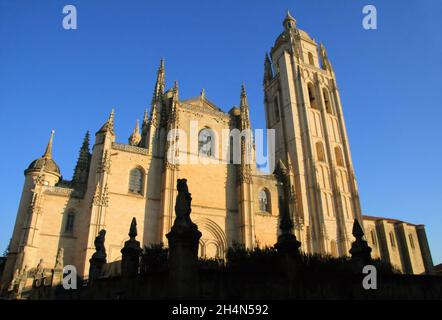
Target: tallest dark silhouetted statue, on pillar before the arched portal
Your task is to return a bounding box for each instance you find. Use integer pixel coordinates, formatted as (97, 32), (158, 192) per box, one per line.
(172, 179), (197, 231)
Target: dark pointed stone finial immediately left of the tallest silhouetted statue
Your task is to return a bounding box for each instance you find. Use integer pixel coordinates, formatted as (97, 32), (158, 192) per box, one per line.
(121, 218), (142, 277)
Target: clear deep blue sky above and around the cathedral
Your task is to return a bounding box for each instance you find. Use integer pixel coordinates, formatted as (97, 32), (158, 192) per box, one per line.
(0, 0), (442, 263)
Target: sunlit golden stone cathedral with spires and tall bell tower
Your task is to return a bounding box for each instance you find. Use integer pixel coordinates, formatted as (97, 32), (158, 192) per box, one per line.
(1, 13), (432, 286)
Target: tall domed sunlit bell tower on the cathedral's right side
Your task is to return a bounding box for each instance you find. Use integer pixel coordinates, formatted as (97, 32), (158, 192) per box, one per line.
(264, 12), (362, 256)
